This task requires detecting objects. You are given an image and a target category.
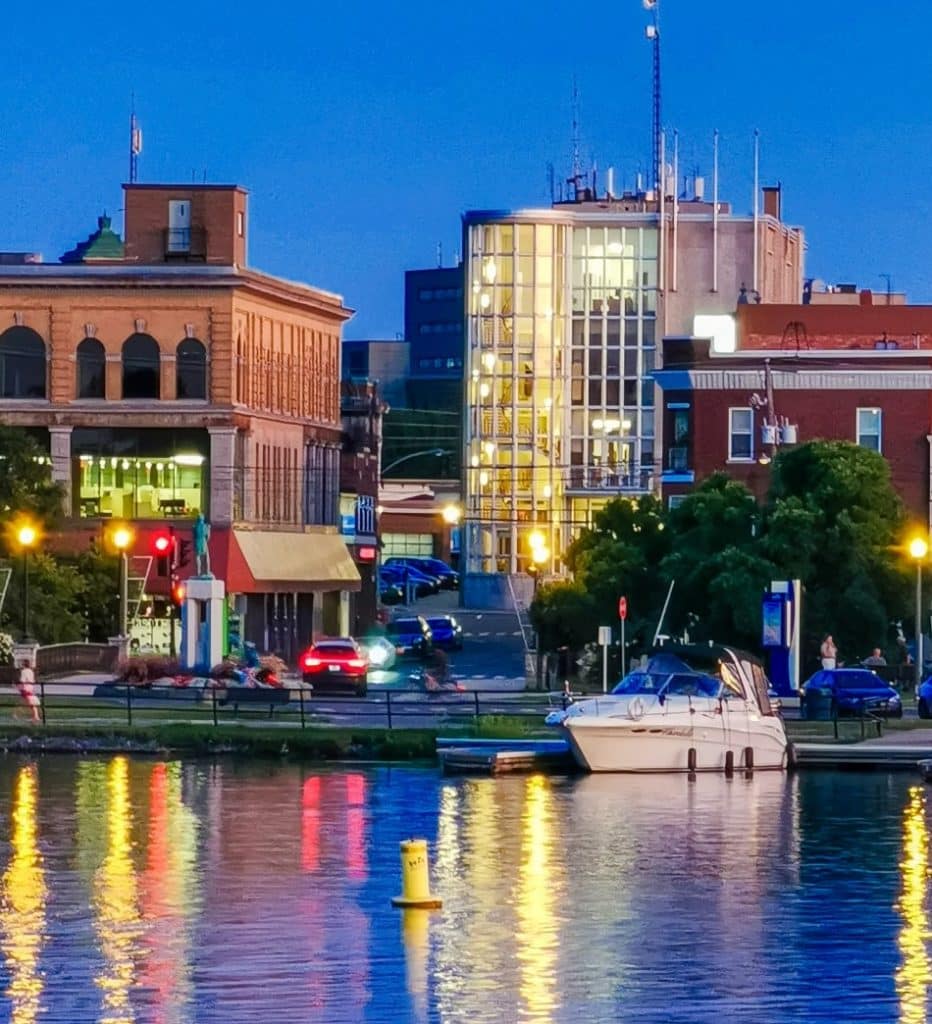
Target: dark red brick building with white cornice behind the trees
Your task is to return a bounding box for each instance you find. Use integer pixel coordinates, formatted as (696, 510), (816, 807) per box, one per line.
(654, 293), (932, 525)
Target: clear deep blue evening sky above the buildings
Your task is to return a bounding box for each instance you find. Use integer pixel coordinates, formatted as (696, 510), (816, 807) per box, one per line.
(0, 0), (932, 338)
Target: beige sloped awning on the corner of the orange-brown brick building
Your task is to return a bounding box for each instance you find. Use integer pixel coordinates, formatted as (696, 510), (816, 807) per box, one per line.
(234, 529), (362, 594)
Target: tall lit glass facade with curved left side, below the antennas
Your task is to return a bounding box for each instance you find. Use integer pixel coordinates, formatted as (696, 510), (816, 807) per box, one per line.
(464, 210), (661, 573)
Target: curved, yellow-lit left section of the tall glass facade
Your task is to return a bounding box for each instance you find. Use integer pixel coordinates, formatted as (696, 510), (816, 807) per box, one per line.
(465, 221), (566, 572)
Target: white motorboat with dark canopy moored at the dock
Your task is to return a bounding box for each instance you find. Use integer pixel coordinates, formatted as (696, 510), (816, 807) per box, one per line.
(548, 645), (789, 772)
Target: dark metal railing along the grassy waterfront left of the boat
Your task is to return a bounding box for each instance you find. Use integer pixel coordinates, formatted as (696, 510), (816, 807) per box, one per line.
(0, 679), (559, 729)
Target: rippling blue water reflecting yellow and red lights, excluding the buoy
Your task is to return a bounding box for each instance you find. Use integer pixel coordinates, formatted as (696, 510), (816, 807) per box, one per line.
(0, 757), (932, 1024)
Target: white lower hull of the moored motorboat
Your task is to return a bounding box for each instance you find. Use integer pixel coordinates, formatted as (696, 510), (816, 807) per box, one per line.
(563, 716), (788, 772)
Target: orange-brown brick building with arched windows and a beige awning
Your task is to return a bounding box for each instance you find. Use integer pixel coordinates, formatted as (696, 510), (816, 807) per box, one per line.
(0, 184), (359, 657)
